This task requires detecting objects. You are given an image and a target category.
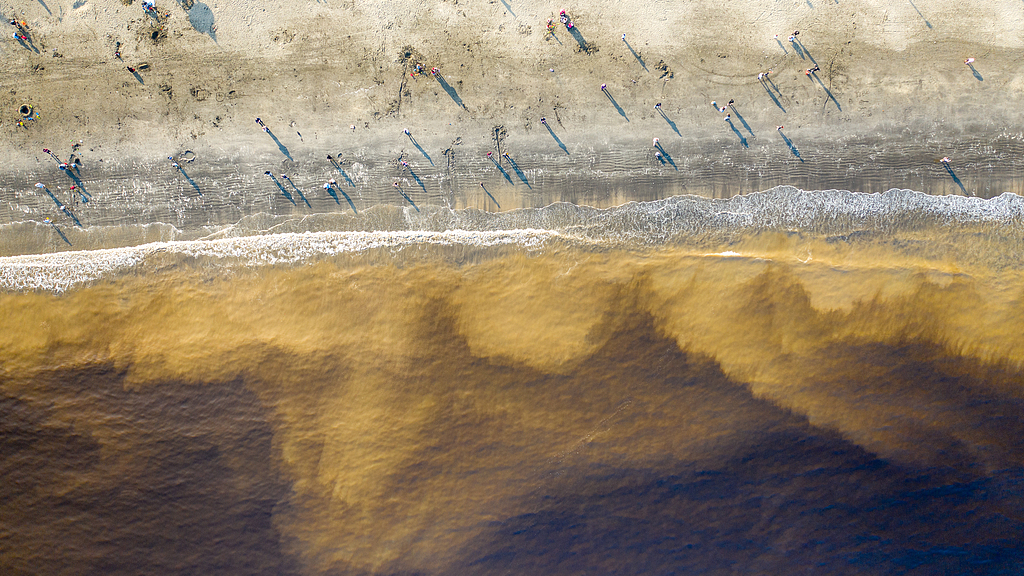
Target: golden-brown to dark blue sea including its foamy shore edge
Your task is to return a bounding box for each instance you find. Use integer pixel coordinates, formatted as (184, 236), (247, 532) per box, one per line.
(0, 188), (1024, 575)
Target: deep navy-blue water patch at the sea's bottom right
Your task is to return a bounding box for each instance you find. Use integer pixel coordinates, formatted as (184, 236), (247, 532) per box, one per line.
(465, 435), (1024, 575)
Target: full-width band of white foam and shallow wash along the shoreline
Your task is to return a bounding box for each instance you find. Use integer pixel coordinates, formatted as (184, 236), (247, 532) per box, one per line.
(0, 187), (1024, 292)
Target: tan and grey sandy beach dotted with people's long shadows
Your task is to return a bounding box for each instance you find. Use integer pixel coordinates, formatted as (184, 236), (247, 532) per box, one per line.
(0, 0), (1024, 253)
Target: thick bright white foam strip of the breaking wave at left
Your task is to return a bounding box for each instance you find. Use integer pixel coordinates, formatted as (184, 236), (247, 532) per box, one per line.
(0, 230), (558, 293)
